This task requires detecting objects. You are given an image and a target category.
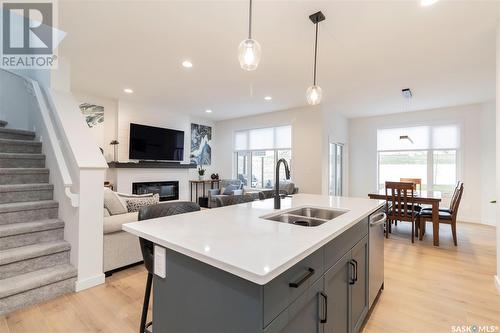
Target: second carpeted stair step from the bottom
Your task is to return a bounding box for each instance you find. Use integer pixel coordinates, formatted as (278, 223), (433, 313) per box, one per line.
(0, 240), (71, 280)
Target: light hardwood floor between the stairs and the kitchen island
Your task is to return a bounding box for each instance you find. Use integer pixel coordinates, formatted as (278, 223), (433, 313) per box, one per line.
(0, 265), (151, 333)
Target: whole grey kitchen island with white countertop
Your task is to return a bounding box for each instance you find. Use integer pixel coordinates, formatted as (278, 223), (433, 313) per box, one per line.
(123, 194), (382, 333)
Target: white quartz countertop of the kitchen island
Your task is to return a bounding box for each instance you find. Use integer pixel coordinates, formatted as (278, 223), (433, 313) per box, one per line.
(123, 194), (382, 285)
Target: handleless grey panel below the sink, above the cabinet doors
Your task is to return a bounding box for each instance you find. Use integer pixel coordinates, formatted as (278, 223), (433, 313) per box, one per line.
(324, 218), (368, 271)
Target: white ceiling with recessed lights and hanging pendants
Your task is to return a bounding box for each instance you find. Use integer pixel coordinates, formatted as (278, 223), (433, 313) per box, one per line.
(59, 0), (499, 120)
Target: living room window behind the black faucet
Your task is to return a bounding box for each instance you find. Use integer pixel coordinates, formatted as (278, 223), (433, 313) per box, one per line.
(234, 126), (292, 188)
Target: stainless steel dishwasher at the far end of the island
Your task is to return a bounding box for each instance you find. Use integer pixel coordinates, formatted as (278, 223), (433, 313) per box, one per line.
(368, 209), (387, 308)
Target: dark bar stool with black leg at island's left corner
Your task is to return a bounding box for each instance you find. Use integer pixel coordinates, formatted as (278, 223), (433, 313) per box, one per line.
(138, 201), (200, 333)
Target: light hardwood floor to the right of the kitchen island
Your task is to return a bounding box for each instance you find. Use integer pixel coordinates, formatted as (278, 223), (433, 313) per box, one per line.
(363, 223), (500, 333)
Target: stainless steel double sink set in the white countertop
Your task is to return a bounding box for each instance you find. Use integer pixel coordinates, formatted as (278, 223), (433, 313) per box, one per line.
(262, 207), (348, 227)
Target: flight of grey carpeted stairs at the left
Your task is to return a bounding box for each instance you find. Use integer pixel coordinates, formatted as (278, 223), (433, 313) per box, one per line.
(0, 121), (77, 315)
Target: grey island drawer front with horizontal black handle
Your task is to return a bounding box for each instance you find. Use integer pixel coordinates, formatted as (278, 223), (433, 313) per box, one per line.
(263, 248), (324, 327)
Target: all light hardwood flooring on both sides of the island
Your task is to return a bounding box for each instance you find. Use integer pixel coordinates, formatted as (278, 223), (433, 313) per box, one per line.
(0, 223), (500, 333)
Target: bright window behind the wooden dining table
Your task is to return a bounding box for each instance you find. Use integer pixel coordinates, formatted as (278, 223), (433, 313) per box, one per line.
(377, 125), (460, 193)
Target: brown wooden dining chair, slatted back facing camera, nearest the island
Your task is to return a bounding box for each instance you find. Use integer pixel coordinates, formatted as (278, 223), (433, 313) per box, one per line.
(385, 182), (418, 243)
